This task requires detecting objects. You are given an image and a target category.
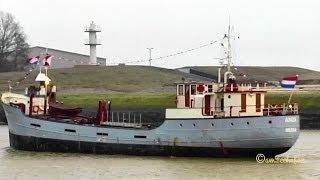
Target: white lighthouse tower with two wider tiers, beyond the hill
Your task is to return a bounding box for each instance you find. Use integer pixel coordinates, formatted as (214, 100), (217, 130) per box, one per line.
(84, 21), (101, 65)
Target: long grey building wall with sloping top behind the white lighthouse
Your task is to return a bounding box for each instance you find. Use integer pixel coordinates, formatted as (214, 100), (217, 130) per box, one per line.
(28, 46), (106, 69)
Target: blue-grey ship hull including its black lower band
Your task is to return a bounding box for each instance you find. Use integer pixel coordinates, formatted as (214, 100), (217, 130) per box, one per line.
(3, 104), (300, 157)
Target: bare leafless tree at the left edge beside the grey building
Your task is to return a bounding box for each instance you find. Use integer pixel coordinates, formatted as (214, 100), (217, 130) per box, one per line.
(0, 11), (29, 71)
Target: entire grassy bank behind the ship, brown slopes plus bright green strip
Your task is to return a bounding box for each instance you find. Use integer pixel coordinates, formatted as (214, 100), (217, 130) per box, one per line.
(0, 66), (320, 107)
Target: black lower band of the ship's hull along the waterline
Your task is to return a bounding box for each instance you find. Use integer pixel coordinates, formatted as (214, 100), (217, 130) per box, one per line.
(9, 133), (290, 157)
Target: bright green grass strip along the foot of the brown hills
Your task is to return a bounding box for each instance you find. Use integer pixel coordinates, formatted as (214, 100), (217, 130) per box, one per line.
(58, 92), (320, 108)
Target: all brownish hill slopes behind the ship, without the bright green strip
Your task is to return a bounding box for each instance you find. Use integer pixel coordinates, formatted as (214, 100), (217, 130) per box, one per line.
(0, 65), (320, 94)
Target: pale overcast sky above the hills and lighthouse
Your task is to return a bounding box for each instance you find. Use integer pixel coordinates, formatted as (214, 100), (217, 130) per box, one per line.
(0, 0), (320, 71)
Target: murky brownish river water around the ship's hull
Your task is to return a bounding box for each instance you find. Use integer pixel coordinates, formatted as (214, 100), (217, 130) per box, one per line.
(0, 126), (320, 180)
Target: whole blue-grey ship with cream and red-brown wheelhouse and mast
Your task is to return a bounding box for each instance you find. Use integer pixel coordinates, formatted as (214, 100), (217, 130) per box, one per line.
(1, 26), (300, 157)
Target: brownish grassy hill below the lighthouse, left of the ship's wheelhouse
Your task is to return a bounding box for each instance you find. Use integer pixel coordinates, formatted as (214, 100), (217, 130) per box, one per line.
(0, 66), (208, 94)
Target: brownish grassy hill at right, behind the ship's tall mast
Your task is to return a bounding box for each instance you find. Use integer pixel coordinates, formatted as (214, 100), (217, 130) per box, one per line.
(186, 66), (320, 84)
